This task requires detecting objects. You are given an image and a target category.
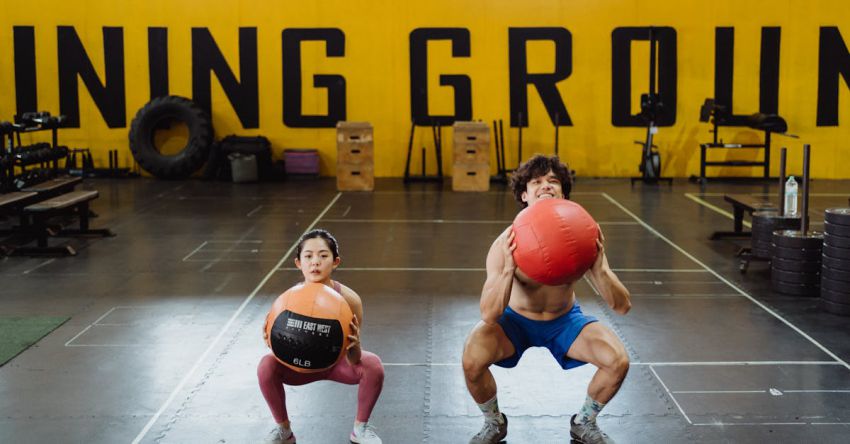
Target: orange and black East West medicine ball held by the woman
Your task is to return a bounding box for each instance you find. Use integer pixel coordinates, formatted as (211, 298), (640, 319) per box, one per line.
(266, 283), (354, 373)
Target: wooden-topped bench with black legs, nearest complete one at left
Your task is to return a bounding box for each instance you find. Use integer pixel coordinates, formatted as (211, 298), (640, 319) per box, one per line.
(14, 190), (114, 256)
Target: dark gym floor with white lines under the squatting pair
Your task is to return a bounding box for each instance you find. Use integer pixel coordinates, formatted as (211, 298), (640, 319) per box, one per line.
(0, 178), (850, 443)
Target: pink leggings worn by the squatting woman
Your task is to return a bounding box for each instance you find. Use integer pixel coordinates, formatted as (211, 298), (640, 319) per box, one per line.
(257, 350), (384, 424)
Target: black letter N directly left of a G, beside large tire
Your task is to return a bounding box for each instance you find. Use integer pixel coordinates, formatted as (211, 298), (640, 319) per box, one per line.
(192, 28), (260, 128)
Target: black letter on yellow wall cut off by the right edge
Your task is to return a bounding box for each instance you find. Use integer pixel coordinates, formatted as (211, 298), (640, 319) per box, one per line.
(817, 26), (850, 126)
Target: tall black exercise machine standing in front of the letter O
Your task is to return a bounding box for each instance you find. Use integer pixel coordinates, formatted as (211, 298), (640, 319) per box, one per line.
(631, 27), (673, 185)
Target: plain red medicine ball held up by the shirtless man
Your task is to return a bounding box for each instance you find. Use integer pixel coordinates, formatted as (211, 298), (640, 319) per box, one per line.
(513, 199), (599, 285)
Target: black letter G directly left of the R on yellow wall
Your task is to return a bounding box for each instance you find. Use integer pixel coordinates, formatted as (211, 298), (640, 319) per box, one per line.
(410, 28), (472, 125)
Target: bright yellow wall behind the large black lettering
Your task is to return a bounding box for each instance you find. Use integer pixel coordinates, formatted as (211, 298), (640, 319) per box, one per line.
(0, 0), (850, 178)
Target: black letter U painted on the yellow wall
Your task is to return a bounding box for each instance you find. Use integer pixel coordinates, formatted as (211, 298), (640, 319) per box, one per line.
(714, 27), (781, 126)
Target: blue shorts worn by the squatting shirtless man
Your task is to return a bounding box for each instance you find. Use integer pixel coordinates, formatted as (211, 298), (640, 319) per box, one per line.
(496, 302), (597, 370)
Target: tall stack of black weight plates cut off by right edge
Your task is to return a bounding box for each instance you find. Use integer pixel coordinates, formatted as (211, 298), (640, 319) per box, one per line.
(821, 208), (850, 316)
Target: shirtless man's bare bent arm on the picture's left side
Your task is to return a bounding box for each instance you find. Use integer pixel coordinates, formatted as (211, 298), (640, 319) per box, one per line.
(480, 228), (516, 324)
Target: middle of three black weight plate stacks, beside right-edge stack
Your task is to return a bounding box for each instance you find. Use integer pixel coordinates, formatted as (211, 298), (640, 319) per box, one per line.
(770, 230), (823, 297)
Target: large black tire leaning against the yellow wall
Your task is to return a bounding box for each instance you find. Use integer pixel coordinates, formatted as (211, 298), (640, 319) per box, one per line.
(130, 96), (213, 179)
